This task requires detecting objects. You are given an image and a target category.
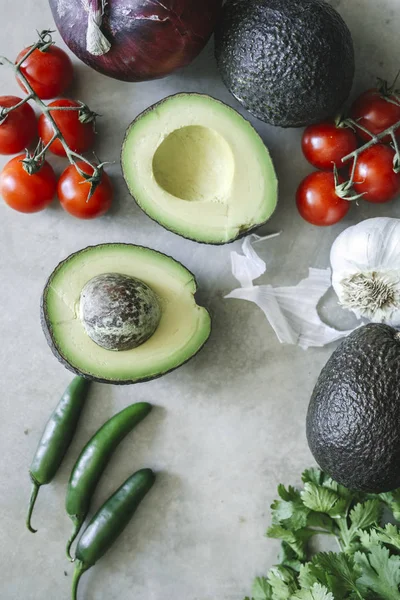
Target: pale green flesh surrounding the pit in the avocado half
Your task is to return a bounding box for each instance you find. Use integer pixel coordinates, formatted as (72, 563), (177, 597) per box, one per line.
(42, 244), (211, 384)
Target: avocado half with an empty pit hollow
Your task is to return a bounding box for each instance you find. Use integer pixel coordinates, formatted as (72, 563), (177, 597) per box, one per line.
(121, 94), (277, 244)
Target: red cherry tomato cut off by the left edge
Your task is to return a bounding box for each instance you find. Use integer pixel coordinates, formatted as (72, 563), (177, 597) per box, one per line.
(0, 96), (37, 154)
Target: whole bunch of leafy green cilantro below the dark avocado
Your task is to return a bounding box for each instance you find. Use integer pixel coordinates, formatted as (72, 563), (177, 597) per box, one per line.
(245, 468), (400, 600)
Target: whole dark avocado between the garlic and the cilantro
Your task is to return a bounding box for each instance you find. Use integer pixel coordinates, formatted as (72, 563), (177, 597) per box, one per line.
(307, 324), (400, 494)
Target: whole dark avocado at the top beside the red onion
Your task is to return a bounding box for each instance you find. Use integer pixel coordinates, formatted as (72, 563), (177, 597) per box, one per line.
(215, 0), (354, 127)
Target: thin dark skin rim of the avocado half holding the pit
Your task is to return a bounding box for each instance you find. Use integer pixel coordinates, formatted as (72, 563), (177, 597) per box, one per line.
(40, 242), (212, 385)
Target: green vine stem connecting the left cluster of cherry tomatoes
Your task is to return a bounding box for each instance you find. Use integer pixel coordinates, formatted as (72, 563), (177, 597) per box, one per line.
(0, 30), (105, 186)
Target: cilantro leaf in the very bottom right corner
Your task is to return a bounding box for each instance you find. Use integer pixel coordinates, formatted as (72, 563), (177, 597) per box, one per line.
(354, 544), (400, 600)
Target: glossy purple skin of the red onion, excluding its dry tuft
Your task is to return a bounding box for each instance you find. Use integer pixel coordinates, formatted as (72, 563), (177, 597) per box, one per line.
(49, 0), (222, 81)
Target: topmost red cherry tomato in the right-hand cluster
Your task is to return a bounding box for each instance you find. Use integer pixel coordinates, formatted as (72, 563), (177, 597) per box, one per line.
(350, 88), (400, 142)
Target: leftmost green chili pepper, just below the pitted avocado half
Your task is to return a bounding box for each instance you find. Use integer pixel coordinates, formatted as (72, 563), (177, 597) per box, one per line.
(26, 377), (91, 533)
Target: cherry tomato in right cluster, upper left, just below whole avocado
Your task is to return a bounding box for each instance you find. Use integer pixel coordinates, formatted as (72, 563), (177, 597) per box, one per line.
(301, 121), (357, 171)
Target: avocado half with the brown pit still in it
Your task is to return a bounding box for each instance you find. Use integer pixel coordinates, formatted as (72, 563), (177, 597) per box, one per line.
(41, 244), (211, 384)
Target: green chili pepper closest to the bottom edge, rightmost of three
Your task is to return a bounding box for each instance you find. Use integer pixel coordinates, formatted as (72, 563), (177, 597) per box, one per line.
(72, 469), (155, 600)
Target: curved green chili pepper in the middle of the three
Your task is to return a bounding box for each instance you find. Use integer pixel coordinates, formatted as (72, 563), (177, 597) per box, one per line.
(65, 402), (152, 561)
